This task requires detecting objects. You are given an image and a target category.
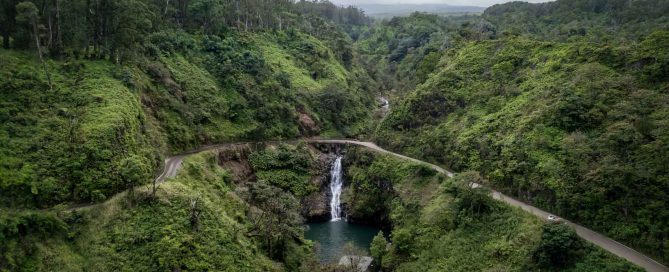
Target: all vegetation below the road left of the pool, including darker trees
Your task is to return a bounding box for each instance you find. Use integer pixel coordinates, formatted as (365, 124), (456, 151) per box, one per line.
(0, 152), (312, 271)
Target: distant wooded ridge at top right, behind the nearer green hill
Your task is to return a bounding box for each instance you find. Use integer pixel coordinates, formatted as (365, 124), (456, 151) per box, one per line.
(483, 0), (669, 41)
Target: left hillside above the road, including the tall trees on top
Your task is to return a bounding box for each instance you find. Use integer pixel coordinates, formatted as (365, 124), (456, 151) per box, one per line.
(0, 0), (375, 208)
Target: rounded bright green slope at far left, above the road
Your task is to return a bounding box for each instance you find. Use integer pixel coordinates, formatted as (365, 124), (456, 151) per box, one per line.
(0, 50), (158, 206)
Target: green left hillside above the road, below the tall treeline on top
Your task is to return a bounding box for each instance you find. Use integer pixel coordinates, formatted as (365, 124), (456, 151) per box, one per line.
(0, 12), (374, 207)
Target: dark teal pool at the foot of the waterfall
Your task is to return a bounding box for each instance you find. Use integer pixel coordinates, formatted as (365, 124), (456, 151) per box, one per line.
(305, 220), (379, 263)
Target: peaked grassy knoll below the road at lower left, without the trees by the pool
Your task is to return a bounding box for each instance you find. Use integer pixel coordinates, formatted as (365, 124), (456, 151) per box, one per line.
(1, 153), (281, 271)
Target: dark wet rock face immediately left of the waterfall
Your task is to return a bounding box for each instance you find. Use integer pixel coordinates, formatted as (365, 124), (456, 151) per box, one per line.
(301, 153), (335, 222)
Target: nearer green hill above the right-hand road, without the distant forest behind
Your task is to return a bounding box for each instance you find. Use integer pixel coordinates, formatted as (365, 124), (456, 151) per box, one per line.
(378, 33), (669, 260)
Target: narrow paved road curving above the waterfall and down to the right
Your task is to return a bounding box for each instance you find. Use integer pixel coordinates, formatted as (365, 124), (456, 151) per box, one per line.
(150, 139), (669, 272)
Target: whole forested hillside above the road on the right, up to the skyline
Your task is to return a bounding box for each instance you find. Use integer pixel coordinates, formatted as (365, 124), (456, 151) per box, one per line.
(356, 0), (669, 262)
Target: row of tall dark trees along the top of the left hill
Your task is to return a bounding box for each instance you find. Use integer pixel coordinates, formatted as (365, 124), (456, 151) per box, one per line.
(0, 0), (369, 61)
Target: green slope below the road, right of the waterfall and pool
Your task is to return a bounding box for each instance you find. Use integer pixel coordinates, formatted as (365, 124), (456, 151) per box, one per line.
(345, 148), (641, 271)
